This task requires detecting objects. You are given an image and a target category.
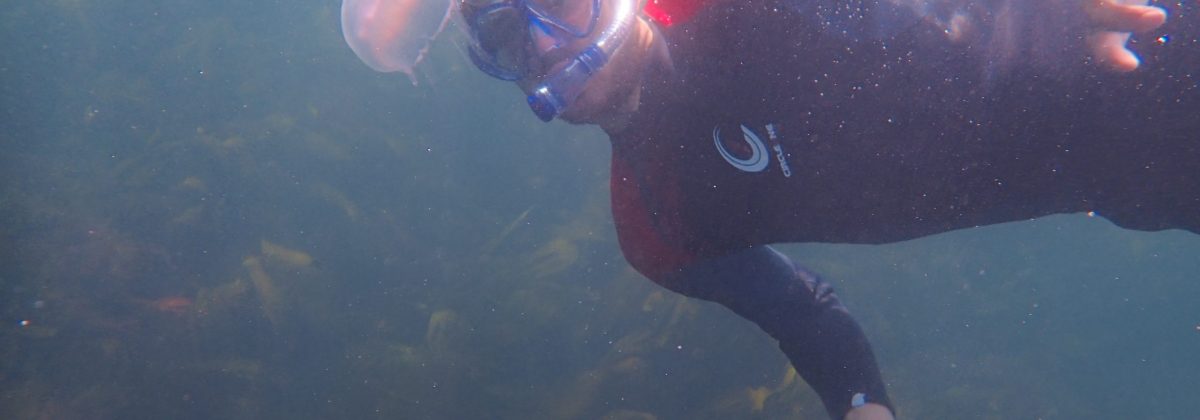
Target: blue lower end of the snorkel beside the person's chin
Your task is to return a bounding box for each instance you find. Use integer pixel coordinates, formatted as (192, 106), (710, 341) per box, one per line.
(526, 46), (608, 122)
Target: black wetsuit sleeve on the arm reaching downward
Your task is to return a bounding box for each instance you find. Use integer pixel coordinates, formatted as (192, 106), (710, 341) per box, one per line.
(659, 246), (895, 420)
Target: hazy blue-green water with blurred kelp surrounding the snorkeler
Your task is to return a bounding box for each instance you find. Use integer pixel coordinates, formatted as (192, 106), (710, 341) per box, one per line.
(0, 0), (1200, 419)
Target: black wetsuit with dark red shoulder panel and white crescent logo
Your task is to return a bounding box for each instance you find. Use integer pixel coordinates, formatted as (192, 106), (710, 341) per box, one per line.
(610, 0), (1200, 419)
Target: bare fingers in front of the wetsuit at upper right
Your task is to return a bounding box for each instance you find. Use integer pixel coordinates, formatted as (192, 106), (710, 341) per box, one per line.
(1084, 0), (1166, 72)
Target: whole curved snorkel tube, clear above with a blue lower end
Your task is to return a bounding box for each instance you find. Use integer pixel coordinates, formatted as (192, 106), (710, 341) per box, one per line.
(526, 0), (637, 122)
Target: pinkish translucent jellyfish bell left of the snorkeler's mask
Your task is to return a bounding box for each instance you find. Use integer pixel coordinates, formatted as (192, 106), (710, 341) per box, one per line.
(342, 0), (454, 84)
